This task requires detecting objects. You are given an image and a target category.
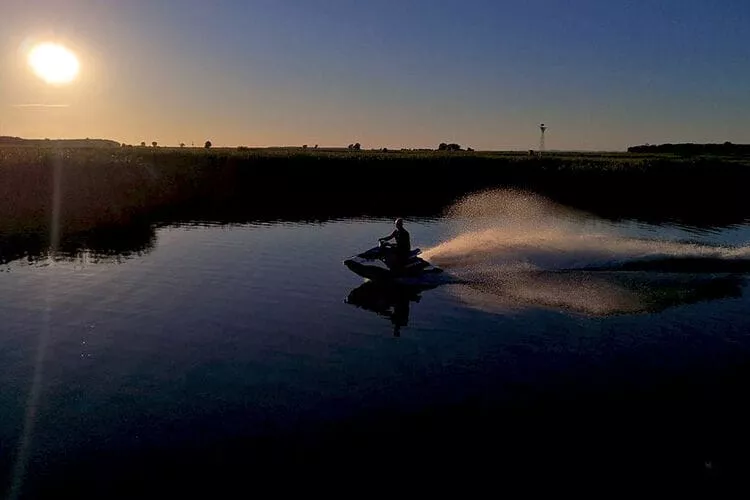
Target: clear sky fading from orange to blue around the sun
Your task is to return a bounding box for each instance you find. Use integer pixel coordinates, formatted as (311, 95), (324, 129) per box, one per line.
(0, 0), (750, 151)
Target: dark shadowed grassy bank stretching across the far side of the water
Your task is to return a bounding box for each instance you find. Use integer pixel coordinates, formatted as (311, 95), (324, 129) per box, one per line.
(0, 148), (750, 261)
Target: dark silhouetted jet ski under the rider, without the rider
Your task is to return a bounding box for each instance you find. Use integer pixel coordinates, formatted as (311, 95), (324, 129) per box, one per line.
(344, 242), (443, 282)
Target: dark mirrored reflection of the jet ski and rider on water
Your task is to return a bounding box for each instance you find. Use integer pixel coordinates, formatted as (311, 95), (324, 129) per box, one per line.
(344, 281), (437, 337)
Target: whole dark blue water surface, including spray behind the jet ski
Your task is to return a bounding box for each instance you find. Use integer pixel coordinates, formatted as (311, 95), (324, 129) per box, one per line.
(0, 191), (750, 498)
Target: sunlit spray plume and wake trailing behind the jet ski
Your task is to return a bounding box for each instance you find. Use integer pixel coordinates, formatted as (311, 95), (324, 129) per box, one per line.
(423, 190), (750, 315)
